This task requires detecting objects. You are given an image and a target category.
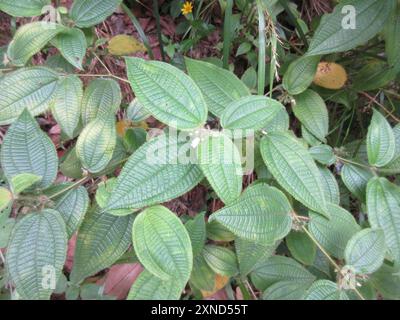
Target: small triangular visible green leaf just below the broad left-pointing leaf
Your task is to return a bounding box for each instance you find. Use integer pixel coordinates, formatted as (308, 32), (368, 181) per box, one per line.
(235, 238), (277, 277)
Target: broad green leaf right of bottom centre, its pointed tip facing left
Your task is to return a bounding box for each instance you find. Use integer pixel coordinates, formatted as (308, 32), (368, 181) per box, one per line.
(209, 183), (292, 244)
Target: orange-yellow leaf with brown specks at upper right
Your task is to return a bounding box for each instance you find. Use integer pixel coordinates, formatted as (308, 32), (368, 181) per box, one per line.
(314, 62), (347, 90)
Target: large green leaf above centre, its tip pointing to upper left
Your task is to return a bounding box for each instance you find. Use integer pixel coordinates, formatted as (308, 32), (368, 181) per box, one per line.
(125, 58), (207, 129)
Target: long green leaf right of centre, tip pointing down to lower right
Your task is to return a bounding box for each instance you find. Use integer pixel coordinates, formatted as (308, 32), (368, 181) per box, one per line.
(260, 132), (329, 217)
